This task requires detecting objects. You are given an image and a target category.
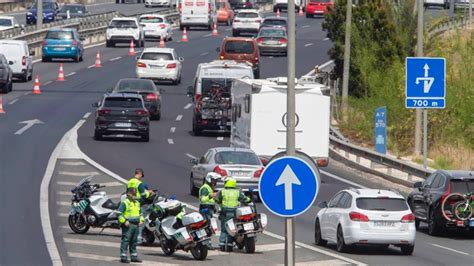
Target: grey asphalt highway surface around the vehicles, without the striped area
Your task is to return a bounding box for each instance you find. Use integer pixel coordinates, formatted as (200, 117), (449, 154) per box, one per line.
(0, 9), (474, 265)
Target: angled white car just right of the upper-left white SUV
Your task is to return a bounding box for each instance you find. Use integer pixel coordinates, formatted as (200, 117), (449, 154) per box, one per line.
(138, 14), (173, 41)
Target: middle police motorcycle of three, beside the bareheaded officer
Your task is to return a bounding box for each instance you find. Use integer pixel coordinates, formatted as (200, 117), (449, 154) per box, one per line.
(142, 197), (219, 260)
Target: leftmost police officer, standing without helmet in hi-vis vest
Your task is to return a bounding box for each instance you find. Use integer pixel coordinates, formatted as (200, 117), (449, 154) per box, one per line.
(118, 188), (144, 263)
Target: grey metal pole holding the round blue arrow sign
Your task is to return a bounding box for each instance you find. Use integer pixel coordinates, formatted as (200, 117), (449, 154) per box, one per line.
(285, 0), (296, 266)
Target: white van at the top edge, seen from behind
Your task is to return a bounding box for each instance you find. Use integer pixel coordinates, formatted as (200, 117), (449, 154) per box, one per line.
(178, 0), (217, 30)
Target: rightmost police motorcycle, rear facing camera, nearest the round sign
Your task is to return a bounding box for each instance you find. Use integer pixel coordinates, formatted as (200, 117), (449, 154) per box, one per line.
(222, 191), (268, 253)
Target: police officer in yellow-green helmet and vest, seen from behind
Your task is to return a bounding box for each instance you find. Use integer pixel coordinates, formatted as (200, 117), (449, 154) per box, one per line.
(216, 177), (251, 251)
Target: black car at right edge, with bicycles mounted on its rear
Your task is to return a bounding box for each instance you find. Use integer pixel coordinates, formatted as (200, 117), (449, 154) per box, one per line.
(407, 170), (474, 235)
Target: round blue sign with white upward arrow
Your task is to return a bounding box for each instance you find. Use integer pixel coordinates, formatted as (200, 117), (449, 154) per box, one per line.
(258, 156), (319, 217)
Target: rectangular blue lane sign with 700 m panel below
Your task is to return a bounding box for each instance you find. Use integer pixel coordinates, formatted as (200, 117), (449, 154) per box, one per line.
(405, 57), (446, 109)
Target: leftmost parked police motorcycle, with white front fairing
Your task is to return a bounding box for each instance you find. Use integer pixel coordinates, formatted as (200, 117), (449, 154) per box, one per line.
(68, 176), (120, 234)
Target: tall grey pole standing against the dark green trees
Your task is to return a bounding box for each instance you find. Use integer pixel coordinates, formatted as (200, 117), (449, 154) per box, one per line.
(341, 0), (352, 120)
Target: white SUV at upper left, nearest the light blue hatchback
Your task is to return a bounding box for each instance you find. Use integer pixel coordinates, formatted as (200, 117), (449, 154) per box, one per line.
(105, 17), (145, 47)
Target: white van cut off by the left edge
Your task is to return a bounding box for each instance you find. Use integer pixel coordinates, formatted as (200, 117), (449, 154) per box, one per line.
(0, 40), (34, 82)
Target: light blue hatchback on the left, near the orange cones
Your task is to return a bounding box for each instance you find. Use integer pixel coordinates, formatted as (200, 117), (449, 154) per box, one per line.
(42, 28), (84, 62)
